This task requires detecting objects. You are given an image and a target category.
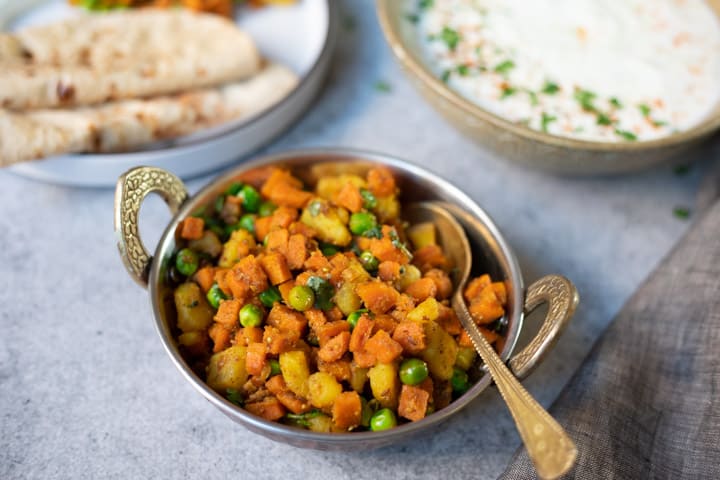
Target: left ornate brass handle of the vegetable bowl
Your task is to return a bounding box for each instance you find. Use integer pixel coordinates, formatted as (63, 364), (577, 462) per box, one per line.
(115, 167), (188, 287)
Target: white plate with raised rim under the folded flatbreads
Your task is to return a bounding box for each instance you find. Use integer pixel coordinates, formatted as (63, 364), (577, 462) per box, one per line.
(0, 0), (338, 187)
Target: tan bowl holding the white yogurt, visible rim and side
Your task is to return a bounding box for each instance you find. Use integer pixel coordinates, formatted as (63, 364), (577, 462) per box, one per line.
(376, 0), (720, 175)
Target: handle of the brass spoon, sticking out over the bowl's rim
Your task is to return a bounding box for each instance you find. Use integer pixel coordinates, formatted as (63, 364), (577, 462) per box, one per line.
(452, 293), (577, 479)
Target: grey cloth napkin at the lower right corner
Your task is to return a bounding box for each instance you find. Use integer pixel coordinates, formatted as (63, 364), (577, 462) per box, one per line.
(501, 172), (720, 480)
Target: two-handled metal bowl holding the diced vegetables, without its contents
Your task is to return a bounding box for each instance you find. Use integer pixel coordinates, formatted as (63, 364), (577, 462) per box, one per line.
(115, 150), (577, 450)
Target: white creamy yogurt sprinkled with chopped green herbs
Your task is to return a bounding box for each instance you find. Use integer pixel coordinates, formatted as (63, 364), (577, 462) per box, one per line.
(408, 0), (720, 142)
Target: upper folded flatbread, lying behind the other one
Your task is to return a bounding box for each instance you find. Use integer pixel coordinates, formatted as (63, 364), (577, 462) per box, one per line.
(0, 9), (260, 110)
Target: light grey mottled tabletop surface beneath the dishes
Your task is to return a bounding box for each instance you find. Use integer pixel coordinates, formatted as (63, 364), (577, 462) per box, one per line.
(0, 0), (720, 480)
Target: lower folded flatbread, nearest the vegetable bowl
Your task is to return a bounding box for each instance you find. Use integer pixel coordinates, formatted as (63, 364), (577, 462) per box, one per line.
(0, 64), (298, 166)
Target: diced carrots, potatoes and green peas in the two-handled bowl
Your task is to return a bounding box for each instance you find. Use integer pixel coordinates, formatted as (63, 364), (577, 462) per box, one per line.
(167, 166), (507, 432)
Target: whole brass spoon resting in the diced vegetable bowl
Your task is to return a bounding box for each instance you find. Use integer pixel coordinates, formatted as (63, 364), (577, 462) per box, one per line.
(403, 202), (577, 479)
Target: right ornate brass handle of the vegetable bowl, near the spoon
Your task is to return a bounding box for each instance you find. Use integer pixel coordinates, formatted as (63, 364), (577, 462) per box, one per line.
(508, 275), (580, 380)
